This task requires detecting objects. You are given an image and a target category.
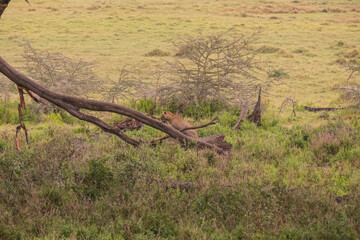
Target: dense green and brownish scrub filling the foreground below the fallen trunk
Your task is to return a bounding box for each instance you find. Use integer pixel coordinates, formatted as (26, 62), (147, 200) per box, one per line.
(0, 110), (360, 239)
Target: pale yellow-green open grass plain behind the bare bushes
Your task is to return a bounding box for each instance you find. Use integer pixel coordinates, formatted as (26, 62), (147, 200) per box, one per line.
(0, 0), (360, 107)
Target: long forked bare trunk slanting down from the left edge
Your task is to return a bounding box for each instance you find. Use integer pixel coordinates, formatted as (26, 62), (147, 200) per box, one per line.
(0, 57), (225, 154)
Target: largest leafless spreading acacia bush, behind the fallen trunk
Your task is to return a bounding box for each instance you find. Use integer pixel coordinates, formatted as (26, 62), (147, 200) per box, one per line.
(159, 31), (263, 107)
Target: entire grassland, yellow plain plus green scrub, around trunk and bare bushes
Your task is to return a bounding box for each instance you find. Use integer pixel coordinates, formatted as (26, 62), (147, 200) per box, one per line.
(0, 0), (360, 239)
